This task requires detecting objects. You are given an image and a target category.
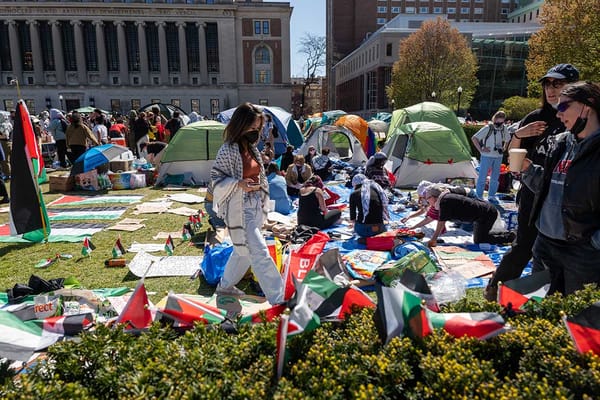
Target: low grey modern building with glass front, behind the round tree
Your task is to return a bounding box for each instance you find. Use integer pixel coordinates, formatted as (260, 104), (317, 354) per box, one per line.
(330, 15), (540, 119)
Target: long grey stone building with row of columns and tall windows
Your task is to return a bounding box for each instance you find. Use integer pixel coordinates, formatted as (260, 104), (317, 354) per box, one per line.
(0, 0), (292, 117)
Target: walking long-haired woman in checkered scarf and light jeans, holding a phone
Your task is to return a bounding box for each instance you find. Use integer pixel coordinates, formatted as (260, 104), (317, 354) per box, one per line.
(211, 103), (283, 304)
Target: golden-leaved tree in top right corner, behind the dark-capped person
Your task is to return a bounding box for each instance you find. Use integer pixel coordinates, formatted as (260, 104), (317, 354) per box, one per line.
(525, 0), (600, 97)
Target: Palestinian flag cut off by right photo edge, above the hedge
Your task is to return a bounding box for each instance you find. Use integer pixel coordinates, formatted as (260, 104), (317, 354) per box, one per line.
(563, 302), (600, 356)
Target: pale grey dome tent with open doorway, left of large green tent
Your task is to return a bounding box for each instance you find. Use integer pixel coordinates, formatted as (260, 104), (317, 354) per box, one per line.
(298, 125), (368, 166)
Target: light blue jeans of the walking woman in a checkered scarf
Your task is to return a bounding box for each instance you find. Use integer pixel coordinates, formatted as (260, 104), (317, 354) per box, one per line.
(221, 192), (283, 304)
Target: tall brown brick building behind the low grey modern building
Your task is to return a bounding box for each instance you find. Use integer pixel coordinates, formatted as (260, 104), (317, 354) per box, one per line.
(326, 0), (519, 108)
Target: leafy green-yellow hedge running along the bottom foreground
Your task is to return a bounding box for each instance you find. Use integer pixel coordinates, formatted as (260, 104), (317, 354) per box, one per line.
(0, 288), (600, 400)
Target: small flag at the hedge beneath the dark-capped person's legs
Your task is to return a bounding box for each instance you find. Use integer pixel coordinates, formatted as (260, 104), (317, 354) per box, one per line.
(498, 270), (550, 311)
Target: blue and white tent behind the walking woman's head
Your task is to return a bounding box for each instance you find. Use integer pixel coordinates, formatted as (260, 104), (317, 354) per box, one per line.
(217, 105), (304, 155)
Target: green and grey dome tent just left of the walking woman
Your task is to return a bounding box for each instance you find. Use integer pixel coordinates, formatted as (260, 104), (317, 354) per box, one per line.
(156, 121), (225, 185)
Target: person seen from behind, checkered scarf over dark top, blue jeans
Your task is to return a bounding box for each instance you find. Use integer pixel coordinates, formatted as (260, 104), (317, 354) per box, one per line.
(350, 174), (389, 237)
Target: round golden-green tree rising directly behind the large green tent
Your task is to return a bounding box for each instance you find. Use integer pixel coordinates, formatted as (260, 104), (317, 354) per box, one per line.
(386, 18), (478, 109)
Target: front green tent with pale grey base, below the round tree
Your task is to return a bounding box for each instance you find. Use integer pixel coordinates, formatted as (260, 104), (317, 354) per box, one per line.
(382, 121), (477, 187)
